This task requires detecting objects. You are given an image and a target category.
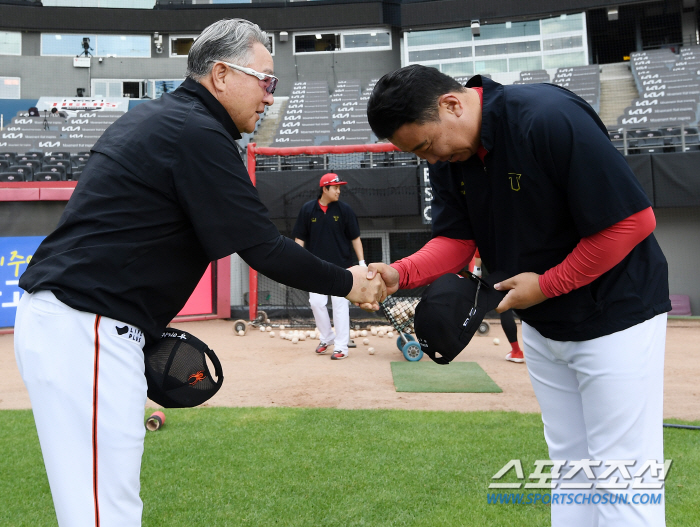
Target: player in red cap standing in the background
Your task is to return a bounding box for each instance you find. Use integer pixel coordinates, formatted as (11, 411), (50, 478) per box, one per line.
(292, 173), (366, 360)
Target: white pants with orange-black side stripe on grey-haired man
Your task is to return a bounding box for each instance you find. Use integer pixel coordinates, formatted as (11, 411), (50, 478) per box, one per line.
(15, 291), (147, 527)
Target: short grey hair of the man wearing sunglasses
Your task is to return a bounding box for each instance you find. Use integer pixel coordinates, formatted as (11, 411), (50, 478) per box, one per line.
(185, 18), (270, 80)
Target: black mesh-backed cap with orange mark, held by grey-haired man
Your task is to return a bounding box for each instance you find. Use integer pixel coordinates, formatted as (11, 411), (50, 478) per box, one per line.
(143, 328), (224, 408)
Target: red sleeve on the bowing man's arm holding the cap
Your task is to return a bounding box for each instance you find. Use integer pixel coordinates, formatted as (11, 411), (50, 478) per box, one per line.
(540, 207), (656, 298)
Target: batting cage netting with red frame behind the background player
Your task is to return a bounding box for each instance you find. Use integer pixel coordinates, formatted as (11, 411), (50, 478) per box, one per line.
(231, 143), (430, 328)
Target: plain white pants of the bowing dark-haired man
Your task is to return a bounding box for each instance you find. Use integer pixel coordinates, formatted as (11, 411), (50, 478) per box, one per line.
(522, 314), (666, 527)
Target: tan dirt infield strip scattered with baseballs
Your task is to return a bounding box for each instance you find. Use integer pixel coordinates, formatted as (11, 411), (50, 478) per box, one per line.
(0, 320), (700, 420)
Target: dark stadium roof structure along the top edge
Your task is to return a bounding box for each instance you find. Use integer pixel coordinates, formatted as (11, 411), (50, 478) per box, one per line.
(0, 0), (656, 34)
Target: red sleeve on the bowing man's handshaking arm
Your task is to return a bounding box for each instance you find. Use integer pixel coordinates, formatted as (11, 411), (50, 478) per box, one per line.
(391, 236), (476, 289)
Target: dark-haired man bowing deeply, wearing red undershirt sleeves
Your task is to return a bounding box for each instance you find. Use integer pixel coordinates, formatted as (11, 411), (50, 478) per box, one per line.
(367, 65), (671, 527)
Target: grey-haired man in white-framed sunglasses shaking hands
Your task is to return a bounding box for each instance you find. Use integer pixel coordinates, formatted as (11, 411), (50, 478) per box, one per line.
(15, 20), (385, 527)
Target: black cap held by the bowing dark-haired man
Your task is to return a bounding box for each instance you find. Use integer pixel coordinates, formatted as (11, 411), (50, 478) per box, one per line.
(413, 272), (508, 364)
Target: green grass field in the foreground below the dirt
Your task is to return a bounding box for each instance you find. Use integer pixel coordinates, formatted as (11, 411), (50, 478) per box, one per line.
(0, 408), (700, 527)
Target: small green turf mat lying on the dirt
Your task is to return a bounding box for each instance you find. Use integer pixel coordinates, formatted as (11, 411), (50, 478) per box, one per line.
(391, 361), (503, 393)
